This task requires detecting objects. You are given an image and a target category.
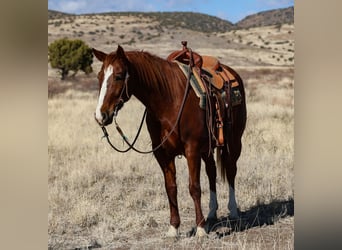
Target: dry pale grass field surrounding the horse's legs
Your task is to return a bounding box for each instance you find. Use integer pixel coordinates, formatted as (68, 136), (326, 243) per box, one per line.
(48, 66), (294, 249)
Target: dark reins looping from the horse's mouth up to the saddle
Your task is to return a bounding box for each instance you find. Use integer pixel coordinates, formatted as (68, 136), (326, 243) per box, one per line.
(101, 48), (192, 154)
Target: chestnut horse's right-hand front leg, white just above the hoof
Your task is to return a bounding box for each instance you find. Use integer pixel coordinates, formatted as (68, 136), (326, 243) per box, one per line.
(185, 146), (206, 236)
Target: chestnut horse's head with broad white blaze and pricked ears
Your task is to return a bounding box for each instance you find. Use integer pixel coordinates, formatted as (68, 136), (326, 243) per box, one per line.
(93, 45), (130, 126)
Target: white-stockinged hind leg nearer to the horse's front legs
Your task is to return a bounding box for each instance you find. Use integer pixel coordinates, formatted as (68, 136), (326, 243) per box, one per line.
(202, 153), (218, 220)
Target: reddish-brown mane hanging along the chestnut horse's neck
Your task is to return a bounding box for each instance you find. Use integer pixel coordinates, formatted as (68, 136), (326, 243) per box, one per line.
(126, 51), (184, 100)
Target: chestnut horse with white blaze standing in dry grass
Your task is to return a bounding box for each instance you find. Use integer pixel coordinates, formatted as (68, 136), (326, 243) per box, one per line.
(93, 45), (246, 237)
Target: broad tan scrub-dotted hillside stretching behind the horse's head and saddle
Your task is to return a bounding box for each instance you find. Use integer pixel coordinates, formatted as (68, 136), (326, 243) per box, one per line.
(48, 8), (294, 66)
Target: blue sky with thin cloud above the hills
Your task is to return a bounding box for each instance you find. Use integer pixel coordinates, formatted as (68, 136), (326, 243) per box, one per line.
(48, 0), (294, 23)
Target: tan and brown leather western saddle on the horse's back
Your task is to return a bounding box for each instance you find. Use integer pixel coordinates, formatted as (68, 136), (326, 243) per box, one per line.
(167, 41), (241, 146)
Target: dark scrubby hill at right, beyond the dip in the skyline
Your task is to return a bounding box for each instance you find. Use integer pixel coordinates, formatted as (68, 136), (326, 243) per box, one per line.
(236, 6), (294, 29)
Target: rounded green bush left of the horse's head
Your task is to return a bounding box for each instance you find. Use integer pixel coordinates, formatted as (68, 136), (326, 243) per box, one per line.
(48, 38), (93, 80)
